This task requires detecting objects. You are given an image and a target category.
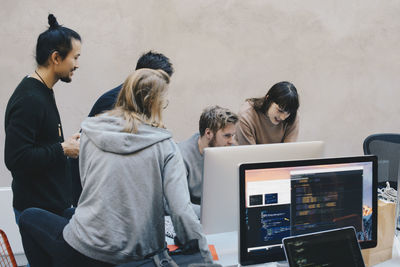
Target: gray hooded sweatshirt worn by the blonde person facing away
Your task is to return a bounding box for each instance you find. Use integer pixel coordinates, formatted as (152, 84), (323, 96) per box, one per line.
(63, 114), (212, 264)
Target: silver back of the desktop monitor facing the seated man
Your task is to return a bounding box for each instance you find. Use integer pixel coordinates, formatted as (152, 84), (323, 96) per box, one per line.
(200, 141), (324, 234)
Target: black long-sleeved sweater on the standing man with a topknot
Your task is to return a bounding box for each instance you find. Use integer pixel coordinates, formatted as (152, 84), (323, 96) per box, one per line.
(4, 77), (71, 214)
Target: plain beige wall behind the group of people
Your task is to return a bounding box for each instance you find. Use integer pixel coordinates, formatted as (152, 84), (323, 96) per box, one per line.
(0, 0), (400, 186)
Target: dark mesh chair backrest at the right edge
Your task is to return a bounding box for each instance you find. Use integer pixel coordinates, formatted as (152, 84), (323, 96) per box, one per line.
(363, 133), (400, 184)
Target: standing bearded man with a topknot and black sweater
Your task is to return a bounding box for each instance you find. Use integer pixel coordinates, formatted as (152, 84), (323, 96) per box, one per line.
(4, 14), (81, 224)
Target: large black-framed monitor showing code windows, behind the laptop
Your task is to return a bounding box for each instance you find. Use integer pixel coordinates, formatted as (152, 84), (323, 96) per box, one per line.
(239, 156), (377, 265)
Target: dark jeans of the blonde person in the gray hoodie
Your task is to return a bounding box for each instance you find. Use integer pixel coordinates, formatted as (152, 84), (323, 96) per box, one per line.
(19, 208), (114, 267)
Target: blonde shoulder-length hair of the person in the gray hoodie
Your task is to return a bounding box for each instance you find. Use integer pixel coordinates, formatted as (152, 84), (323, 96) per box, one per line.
(108, 69), (169, 133)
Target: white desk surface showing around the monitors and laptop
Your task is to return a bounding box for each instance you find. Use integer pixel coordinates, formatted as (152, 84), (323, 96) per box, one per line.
(207, 232), (400, 267)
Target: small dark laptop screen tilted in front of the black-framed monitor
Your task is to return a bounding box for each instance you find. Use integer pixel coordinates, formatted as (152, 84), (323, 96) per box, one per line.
(283, 227), (365, 267)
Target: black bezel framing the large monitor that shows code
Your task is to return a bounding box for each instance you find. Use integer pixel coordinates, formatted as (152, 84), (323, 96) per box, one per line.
(239, 155), (378, 265)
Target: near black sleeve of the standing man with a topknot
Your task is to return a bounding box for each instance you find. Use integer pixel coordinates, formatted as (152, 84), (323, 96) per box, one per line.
(4, 96), (66, 171)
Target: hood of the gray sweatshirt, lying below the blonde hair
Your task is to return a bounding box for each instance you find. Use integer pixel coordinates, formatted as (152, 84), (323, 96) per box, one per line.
(81, 114), (172, 154)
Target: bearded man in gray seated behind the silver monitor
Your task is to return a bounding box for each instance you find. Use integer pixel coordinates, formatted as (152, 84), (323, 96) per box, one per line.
(178, 106), (238, 217)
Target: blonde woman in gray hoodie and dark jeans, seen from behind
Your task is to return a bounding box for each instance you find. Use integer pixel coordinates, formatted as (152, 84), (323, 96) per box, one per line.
(20, 69), (212, 267)
